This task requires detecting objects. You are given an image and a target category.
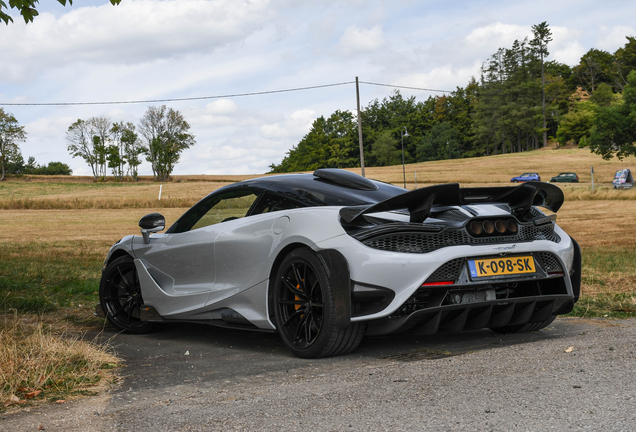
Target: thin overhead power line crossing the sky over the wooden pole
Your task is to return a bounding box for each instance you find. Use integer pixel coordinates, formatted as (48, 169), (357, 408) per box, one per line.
(0, 81), (450, 106)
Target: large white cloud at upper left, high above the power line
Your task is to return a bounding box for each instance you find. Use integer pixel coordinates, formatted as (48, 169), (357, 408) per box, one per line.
(0, 0), (271, 81)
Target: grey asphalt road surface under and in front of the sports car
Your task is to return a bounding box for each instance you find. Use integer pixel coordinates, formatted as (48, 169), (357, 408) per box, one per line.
(0, 319), (636, 432)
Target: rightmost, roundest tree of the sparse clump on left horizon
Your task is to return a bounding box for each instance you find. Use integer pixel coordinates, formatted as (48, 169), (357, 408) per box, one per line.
(139, 105), (196, 182)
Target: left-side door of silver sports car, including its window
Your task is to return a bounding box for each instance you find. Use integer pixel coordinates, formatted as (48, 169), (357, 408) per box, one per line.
(133, 188), (260, 303)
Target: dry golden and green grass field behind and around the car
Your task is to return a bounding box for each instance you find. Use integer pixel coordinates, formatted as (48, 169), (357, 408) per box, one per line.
(0, 149), (636, 411)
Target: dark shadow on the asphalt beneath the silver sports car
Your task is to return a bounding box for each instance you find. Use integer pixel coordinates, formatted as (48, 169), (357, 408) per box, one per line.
(87, 319), (593, 400)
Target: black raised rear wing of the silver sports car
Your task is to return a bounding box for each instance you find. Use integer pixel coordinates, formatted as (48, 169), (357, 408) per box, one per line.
(340, 181), (564, 223)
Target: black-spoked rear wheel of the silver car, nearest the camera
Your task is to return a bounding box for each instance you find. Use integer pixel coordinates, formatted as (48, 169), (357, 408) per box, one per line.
(272, 248), (366, 358)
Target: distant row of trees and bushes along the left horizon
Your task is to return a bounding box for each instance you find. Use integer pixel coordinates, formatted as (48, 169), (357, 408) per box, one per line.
(0, 105), (196, 182)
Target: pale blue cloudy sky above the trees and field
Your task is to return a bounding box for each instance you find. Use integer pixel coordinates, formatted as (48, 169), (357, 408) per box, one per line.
(0, 0), (636, 175)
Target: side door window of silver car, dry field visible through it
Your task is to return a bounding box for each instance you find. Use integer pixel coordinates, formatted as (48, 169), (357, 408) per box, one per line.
(167, 189), (260, 233)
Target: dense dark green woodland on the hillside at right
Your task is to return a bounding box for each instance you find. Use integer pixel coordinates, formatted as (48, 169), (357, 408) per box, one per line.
(270, 22), (636, 173)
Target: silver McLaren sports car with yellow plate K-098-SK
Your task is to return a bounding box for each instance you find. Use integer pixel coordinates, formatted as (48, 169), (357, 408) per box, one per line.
(97, 169), (581, 358)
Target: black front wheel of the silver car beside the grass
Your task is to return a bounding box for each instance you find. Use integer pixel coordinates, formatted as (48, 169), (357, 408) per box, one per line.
(99, 255), (157, 334)
